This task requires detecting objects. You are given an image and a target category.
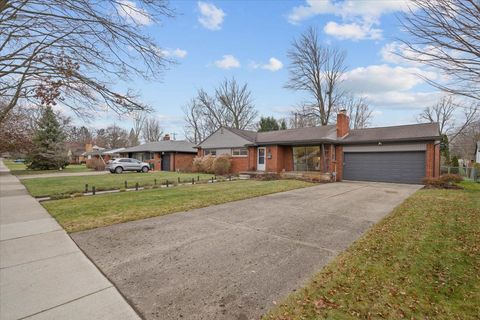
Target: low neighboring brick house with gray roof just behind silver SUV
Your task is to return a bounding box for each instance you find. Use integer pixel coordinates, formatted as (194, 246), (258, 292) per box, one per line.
(122, 135), (197, 171)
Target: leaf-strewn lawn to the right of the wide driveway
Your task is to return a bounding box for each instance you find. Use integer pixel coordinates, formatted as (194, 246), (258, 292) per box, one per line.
(264, 182), (480, 320)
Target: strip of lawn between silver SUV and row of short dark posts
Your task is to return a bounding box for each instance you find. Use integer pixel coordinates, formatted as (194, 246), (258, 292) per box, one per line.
(22, 171), (213, 197)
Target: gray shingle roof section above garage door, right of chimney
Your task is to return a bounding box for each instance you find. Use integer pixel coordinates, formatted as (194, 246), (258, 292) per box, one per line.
(341, 123), (440, 143)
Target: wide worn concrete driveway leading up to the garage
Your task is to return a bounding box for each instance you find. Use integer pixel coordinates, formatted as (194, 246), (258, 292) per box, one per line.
(72, 182), (421, 320)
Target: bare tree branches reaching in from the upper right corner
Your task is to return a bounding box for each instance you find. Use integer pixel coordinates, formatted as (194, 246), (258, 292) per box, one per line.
(401, 0), (480, 100)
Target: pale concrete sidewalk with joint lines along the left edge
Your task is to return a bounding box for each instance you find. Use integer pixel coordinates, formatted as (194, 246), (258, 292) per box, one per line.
(0, 160), (140, 320)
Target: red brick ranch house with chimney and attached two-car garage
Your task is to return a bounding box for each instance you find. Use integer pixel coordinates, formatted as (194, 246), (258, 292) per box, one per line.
(197, 111), (440, 183)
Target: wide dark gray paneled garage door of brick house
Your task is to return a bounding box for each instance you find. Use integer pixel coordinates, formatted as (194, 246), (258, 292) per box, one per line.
(343, 151), (425, 183)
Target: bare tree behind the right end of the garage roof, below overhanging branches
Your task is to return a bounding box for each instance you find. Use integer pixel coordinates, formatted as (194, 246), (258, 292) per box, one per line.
(418, 96), (479, 141)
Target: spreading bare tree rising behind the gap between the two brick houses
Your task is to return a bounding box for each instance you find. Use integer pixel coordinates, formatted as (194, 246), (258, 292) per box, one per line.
(183, 78), (258, 143)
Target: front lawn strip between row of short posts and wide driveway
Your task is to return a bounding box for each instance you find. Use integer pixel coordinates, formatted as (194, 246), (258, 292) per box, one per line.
(42, 180), (312, 232)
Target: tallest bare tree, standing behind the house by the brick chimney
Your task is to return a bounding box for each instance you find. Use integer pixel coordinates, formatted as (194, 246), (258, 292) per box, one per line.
(285, 27), (346, 125)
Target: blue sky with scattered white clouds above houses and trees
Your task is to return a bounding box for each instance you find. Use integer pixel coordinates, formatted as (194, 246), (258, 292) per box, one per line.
(73, 0), (441, 139)
